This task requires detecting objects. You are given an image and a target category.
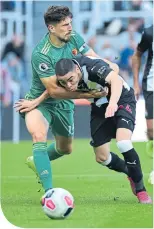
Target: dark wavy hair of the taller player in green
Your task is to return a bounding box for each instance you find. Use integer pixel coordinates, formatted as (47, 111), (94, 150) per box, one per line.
(44, 6), (73, 27)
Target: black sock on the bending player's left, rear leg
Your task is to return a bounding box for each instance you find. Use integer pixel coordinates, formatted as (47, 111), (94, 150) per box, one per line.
(106, 152), (128, 175)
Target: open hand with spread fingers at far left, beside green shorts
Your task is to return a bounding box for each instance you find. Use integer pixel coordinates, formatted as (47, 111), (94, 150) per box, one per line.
(13, 99), (38, 113)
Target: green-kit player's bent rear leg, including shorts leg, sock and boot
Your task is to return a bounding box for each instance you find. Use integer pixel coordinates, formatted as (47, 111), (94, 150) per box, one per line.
(26, 102), (74, 182)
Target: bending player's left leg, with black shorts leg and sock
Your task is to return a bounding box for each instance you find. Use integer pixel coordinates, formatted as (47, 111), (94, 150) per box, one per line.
(90, 104), (128, 174)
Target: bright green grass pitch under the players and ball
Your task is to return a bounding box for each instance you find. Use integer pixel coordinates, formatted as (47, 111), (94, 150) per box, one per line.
(1, 139), (152, 228)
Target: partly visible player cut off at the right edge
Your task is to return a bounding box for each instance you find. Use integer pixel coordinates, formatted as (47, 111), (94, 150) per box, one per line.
(132, 25), (154, 156)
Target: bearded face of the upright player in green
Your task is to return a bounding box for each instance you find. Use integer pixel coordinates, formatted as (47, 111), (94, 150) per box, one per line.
(53, 17), (72, 42)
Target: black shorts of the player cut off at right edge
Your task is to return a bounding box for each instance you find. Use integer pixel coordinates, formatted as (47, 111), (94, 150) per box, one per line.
(143, 91), (153, 119)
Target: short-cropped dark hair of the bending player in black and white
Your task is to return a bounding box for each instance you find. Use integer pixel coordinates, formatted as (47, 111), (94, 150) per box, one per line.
(55, 58), (75, 76)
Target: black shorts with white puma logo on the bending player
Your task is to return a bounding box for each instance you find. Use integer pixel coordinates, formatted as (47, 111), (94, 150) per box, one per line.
(90, 102), (136, 147)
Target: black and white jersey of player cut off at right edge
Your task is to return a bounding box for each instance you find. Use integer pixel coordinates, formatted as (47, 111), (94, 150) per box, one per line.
(137, 25), (154, 91)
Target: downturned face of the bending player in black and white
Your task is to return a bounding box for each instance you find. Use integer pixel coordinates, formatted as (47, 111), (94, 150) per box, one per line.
(57, 68), (81, 91)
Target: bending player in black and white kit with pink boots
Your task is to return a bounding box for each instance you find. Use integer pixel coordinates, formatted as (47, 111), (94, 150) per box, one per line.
(51, 56), (152, 204)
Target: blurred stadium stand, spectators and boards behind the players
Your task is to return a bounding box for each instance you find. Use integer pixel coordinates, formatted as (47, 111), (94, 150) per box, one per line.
(0, 0), (153, 143)
